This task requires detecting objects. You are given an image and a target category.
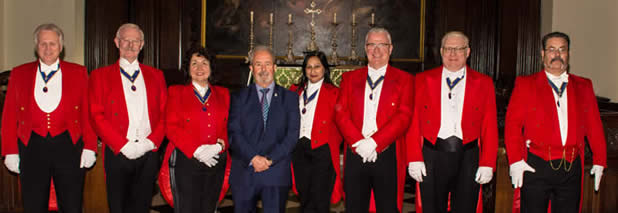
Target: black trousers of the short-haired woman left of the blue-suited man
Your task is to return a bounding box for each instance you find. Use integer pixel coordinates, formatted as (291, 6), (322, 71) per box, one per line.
(169, 149), (227, 213)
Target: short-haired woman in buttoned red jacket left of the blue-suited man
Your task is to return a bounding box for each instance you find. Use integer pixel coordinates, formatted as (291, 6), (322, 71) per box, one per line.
(164, 47), (230, 212)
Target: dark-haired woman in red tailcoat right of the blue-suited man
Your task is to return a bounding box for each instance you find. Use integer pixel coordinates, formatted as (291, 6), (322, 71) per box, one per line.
(290, 52), (342, 212)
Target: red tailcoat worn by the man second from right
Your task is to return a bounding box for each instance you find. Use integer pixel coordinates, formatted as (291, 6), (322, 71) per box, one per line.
(406, 66), (498, 212)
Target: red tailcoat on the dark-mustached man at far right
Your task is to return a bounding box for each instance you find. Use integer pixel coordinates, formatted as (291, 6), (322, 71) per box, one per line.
(504, 70), (607, 211)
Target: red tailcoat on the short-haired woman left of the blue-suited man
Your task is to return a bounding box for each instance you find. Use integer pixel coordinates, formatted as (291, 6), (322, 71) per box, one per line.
(159, 85), (231, 206)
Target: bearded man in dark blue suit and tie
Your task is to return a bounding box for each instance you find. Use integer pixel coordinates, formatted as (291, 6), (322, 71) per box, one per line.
(228, 46), (300, 213)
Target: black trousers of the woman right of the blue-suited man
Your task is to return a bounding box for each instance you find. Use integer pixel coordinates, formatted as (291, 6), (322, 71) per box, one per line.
(292, 137), (337, 213)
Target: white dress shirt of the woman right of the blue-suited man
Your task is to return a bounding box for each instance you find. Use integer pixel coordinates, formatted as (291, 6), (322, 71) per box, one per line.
(298, 79), (324, 140)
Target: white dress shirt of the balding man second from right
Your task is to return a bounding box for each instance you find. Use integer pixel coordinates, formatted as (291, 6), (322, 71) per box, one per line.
(438, 67), (467, 139)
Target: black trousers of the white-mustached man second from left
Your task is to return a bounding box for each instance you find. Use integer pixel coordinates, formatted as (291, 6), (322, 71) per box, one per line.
(105, 147), (159, 213)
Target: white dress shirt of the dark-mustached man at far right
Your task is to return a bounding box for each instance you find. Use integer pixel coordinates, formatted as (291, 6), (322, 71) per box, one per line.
(545, 71), (569, 146)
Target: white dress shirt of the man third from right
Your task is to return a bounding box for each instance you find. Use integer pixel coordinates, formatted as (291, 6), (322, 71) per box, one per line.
(362, 65), (388, 138)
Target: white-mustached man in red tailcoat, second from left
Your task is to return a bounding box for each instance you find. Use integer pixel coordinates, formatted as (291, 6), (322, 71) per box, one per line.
(88, 23), (167, 213)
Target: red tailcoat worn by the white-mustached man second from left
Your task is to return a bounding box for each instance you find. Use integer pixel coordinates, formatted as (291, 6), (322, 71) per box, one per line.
(88, 62), (167, 154)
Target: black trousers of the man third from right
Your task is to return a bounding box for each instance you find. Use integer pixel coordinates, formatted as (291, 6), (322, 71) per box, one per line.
(343, 142), (399, 213)
